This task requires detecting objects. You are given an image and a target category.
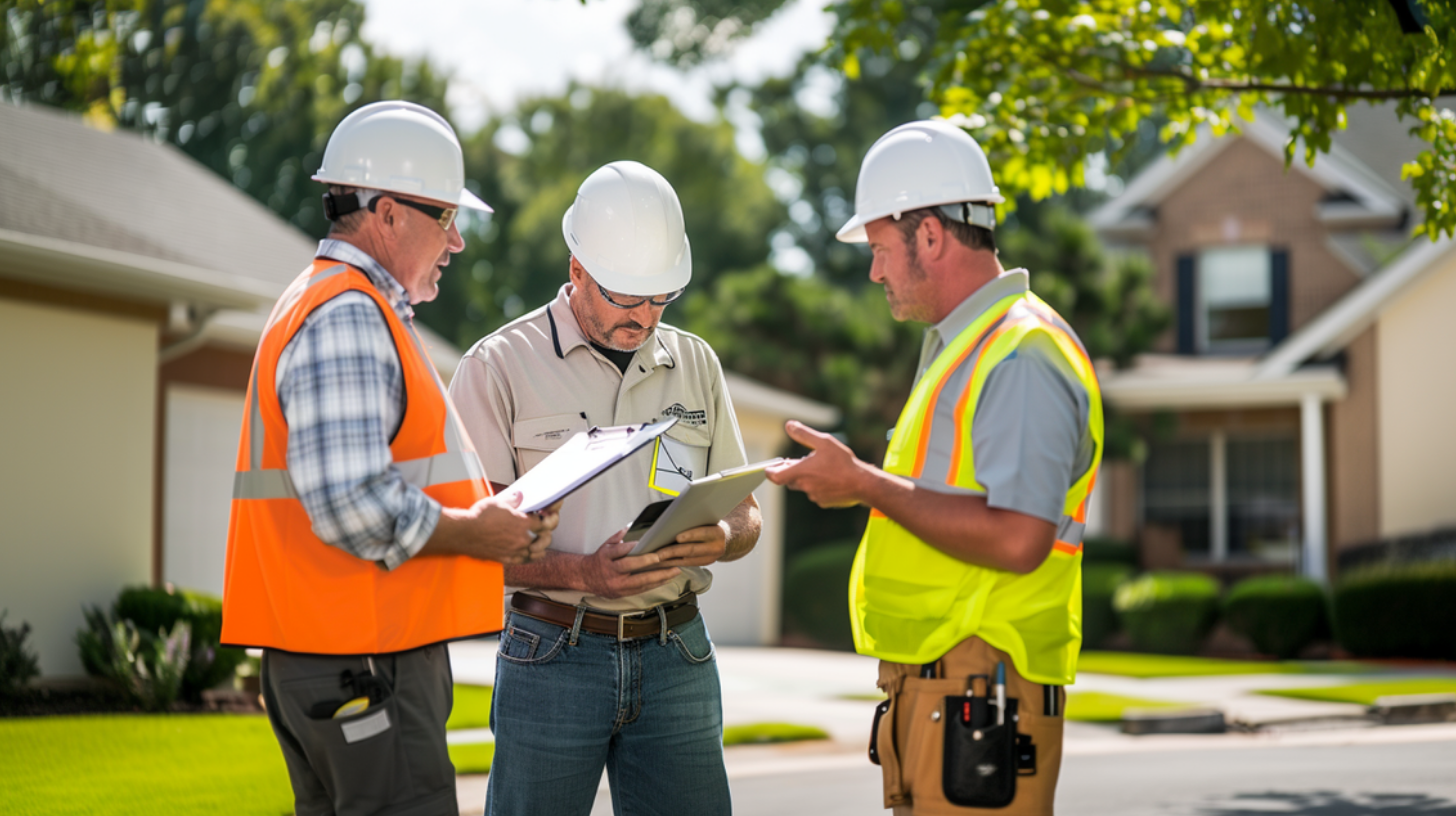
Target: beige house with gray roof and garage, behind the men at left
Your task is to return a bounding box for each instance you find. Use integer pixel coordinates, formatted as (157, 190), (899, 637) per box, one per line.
(0, 105), (837, 678)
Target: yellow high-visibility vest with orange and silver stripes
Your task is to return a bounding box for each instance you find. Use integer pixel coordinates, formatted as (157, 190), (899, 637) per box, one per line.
(849, 293), (1102, 685)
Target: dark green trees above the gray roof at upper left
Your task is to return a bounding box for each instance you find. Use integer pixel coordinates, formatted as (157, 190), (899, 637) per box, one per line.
(0, 0), (446, 235)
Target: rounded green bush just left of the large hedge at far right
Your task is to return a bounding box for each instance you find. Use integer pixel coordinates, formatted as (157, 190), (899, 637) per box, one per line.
(1223, 576), (1329, 660)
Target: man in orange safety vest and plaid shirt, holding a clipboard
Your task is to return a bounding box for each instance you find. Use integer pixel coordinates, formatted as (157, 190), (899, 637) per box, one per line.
(221, 102), (556, 816)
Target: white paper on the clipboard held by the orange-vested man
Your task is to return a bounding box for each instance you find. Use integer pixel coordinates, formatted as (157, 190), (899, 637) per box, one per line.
(502, 417), (677, 513)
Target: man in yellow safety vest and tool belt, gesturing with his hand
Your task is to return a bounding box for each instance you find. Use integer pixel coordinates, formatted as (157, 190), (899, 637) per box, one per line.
(770, 121), (1102, 815)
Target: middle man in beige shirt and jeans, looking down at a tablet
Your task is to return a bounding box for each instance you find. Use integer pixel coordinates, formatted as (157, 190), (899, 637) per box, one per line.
(450, 162), (760, 816)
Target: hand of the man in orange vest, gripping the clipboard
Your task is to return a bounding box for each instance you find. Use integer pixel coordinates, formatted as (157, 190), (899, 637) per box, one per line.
(419, 493), (561, 564)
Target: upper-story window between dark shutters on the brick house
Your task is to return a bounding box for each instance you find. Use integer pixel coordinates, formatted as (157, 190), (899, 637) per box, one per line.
(1197, 246), (1271, 351)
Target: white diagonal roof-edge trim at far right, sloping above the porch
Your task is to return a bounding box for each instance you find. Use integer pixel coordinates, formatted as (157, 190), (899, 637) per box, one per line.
(1254, 238), (1456, 380)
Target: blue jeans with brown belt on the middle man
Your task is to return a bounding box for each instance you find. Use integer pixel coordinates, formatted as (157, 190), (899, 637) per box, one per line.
(485, 612), (731, 816)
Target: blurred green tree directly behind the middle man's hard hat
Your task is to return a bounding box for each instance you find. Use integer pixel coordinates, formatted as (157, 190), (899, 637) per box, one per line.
(419, 86), (783, 345)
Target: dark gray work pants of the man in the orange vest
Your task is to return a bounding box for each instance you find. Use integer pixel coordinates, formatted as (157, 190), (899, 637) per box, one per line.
(262, 644), (460, 816)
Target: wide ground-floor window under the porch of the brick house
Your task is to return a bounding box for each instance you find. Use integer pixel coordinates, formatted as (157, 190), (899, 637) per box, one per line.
(1143, 431), (1300, 564)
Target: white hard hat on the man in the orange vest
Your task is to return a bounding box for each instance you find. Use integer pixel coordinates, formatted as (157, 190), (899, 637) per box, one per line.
(313, 102), (494, 213)
